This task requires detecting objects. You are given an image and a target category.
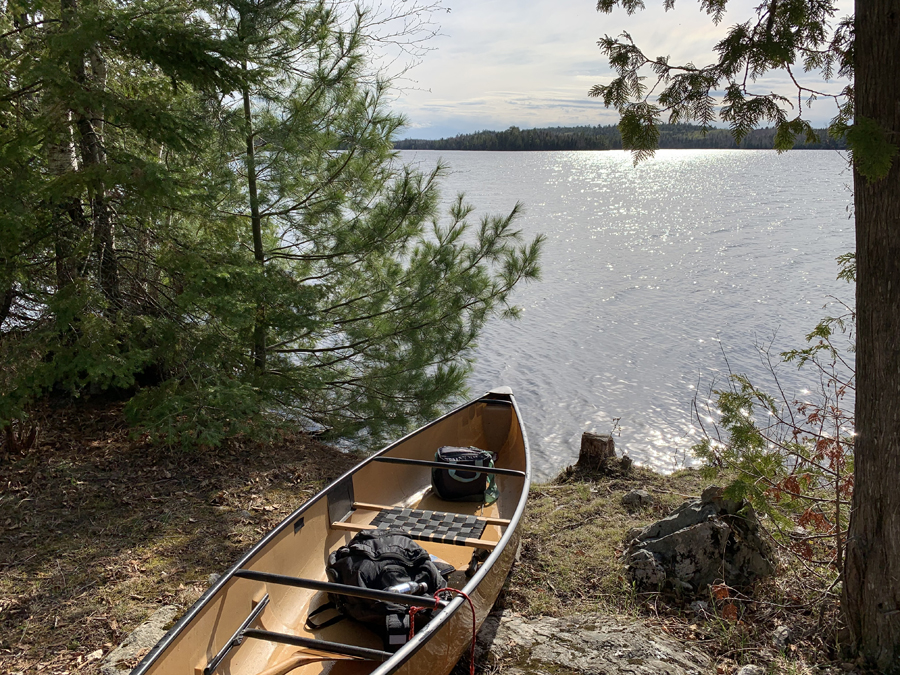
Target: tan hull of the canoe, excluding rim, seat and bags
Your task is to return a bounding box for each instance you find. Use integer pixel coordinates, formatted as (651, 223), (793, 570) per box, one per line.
(142, 397), (528, 675)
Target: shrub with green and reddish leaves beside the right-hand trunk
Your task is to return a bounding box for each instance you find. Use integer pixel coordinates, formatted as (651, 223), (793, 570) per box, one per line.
(693, 270), (855, 577)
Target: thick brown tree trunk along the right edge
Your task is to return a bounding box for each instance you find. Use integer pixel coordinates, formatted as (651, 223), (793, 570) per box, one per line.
(841, 0), (900, 673)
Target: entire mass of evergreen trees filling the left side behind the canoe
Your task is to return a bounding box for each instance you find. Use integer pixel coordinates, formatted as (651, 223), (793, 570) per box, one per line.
(0, 0), (540, 446)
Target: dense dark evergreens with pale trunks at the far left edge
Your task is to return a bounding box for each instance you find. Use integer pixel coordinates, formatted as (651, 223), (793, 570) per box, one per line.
(0, 0), (246, 420)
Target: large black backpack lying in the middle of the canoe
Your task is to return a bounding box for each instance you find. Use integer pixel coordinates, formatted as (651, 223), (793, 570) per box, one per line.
(306, 530), (453, 652)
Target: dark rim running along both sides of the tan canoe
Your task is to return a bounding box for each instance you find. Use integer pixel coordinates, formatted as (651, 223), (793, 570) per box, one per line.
(130, 391), (531, 675)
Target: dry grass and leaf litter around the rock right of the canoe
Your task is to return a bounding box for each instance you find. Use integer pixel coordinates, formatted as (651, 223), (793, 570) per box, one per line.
(502, 468), (843, 675)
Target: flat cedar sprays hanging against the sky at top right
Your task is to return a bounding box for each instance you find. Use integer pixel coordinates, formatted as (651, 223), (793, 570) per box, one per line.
(588, 0), (876, 169)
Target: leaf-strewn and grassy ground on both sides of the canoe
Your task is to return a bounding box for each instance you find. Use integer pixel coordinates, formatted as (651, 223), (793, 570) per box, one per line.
(0, 404), (836, 675)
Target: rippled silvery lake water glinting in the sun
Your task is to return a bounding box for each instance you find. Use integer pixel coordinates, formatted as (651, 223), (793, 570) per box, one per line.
(401, 150), (854, 478)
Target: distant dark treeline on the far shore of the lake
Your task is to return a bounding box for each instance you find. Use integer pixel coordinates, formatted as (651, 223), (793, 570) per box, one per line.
(394, 124), (846, 151)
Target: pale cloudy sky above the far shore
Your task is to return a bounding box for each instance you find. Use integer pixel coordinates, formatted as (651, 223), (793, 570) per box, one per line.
(384, 0), (850, 139)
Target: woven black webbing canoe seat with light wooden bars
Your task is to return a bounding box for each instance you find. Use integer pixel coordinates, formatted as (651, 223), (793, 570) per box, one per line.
(331, 504), (509, 549)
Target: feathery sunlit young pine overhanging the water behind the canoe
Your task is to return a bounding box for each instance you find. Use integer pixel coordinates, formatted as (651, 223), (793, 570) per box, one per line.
(123, 0), (539, 442)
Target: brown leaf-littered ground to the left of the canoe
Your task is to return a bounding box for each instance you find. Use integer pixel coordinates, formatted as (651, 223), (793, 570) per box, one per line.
(0, 403), (360, 675)
